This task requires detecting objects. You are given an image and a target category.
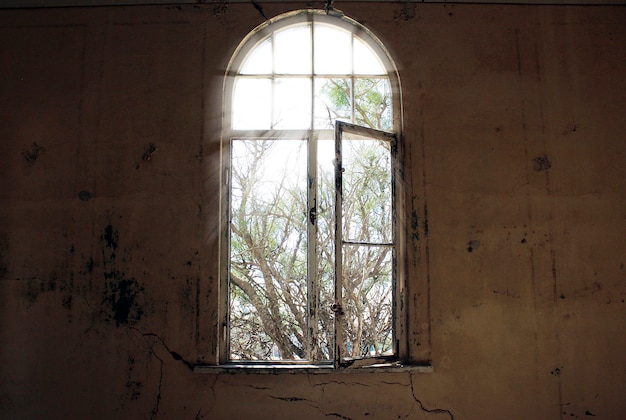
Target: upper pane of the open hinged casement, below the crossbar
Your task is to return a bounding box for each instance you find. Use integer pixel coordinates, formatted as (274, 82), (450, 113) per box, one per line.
(342, 137), (393, 243)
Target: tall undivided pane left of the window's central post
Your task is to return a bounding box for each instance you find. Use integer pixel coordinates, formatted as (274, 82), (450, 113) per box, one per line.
(229, 139), (308, 360)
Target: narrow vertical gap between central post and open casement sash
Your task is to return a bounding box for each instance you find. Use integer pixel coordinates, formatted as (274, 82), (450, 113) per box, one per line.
(312, 139), (335, 360)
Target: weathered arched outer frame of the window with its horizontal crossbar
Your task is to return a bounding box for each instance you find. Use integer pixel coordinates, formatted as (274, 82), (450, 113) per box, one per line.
(216, 10), (410, 370)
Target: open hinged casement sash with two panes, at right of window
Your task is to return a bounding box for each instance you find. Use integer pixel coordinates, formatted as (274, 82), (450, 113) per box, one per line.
(331, 121), (398, 366)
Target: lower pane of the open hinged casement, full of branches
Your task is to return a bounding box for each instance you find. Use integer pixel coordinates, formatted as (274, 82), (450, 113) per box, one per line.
(342, 245), (394, 360)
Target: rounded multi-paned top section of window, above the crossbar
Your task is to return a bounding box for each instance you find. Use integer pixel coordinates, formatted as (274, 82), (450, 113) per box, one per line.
(225, 10), (400, 131)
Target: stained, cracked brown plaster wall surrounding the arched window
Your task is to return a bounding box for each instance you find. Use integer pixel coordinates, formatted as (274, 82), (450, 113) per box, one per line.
(0, 2), (626, 419)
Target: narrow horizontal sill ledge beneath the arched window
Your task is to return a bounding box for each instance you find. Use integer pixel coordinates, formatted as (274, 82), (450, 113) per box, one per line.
(193, 363), (433, 375)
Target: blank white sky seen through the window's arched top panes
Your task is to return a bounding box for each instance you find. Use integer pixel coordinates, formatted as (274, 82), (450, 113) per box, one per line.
(232, 23), (386, 130)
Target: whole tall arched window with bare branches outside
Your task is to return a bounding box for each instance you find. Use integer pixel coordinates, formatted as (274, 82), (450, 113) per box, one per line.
(220, 10), (404, 367)
